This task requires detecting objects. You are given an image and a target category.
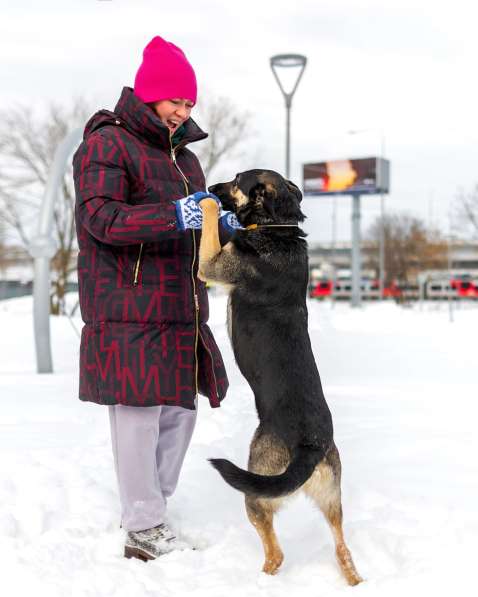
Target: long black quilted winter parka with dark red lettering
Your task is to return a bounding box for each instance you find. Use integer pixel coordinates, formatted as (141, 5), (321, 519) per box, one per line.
(73, 87), (228, 409)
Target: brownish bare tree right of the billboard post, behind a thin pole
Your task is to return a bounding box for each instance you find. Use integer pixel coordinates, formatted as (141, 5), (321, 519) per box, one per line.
(366, 214), (447, 286)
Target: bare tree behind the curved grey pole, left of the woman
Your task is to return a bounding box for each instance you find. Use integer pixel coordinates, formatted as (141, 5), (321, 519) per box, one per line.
(0, 99), (90, 314)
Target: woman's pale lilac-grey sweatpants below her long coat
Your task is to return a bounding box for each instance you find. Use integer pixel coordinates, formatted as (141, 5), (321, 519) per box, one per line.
(108, 400), (197, 531)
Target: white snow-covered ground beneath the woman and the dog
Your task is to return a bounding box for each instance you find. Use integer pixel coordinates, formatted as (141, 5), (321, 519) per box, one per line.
(0, 296), (478, 597)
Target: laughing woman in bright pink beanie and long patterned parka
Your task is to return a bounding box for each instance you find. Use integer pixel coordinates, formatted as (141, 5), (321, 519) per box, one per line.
(73, 37), (237, 560)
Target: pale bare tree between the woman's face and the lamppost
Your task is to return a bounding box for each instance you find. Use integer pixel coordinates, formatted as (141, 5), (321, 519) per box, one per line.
(194, 95), (253, 179)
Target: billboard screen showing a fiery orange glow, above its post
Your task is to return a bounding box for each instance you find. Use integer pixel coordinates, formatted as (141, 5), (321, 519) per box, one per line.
(303, 157), (390, 196)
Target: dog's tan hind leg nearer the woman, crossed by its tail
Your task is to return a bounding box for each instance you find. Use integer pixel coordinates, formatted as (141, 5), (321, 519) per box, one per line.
(246, 428), (290, 574)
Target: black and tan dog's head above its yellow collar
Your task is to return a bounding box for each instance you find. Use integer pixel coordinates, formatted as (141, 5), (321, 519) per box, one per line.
(209, 170), (305, 226)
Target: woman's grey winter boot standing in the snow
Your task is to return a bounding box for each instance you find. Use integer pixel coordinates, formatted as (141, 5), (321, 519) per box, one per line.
(124, 522), (190, 562)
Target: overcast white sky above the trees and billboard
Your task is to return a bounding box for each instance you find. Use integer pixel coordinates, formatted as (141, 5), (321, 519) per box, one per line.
(0, 0), (478, 242)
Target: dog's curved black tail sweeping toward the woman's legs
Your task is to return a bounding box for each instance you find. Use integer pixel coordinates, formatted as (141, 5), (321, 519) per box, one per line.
(209, 446), (325, 498)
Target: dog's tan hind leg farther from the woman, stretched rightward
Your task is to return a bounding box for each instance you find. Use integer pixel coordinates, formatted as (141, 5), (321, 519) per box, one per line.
(303, 445), (362, 585)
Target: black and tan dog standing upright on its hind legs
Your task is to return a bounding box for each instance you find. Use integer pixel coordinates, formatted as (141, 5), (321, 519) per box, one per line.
(199, 170), (362, 585)
